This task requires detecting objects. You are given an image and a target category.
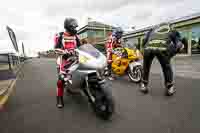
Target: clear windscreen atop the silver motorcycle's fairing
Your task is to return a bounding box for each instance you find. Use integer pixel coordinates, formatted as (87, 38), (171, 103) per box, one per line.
(79, 44), (100, 58)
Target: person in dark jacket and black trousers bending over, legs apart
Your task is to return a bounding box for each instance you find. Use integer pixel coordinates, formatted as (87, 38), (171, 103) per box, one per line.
(140, 23), (184, 96)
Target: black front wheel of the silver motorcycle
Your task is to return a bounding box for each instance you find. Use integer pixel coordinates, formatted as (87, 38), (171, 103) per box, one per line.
(92, 86), (115, 120)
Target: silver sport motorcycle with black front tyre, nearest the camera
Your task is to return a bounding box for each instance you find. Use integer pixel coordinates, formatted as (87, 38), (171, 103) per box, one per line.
(55, 44), (114, 119)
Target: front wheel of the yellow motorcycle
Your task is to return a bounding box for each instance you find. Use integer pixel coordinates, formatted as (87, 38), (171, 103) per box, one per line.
(128, 66), (142, 83)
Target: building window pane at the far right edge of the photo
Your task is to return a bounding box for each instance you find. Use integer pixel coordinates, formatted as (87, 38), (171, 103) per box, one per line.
(191, 25), (200, 54)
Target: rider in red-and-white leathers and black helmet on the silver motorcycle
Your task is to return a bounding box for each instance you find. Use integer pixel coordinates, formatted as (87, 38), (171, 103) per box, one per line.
(54, 18), (80, 108)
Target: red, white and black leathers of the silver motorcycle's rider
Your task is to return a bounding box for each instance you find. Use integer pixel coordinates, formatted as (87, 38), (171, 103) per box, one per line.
(54, 32), (80, 105)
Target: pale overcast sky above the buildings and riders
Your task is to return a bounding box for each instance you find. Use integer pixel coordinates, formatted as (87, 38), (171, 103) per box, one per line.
(0, 0), (200, 54)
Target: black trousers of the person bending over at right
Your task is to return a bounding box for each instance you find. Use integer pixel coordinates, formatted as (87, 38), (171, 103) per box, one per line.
(143, 49), (173, 87)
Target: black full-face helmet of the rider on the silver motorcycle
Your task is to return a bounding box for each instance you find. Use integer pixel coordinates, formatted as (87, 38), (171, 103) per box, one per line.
(64, 18), (78, 35)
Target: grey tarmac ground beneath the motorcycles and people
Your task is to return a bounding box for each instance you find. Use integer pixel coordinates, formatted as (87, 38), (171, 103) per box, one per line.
(0, 58), (200, 133)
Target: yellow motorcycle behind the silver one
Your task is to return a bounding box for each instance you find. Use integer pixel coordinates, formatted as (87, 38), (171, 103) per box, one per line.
(107, 47), (143, 83)
